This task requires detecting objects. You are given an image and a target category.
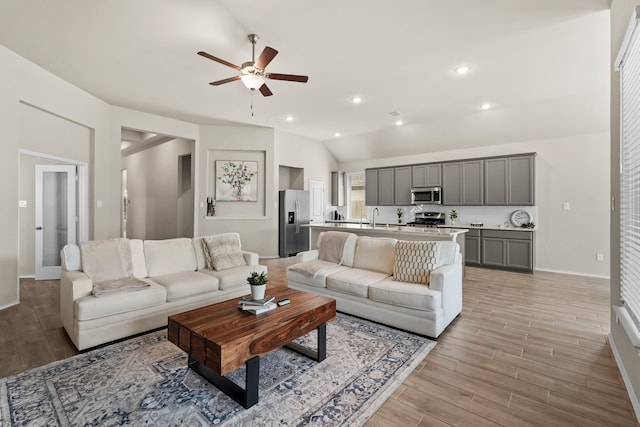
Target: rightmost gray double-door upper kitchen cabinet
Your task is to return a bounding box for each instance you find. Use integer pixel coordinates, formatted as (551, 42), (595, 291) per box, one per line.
(484, 154), (535, 206)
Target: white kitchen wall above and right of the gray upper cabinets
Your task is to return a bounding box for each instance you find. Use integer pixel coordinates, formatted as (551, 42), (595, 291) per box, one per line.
(339, 133), (610, 277)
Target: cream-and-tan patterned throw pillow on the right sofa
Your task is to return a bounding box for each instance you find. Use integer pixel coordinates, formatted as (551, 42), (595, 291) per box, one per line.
(393, 240), (440, 285)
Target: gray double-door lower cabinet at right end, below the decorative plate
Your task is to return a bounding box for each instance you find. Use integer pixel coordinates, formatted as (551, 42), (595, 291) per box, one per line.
(481, 230), (534, 271)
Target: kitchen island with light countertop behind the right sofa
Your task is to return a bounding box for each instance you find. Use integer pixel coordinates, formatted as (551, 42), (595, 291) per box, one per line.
(303, 223), (469, 271)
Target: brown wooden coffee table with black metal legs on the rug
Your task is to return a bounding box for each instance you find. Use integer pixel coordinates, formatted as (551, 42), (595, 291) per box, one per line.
(168, 287), (336, 408)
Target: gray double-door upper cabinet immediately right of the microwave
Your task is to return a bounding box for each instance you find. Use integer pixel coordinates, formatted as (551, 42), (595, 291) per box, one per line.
(442, 159), (484, 206)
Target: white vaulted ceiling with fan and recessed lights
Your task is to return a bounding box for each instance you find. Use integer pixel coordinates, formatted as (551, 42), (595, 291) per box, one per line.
(0, 0), (610, 162)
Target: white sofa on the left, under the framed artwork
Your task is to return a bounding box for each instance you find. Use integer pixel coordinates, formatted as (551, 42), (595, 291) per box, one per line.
(60, 233), (267, 350)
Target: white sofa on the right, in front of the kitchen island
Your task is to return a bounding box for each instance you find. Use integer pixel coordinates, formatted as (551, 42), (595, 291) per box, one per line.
(287, 231), (462, 338)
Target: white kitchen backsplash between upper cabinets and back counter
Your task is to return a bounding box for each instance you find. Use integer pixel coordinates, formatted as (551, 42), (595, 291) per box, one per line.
(327, 205), (540, 227)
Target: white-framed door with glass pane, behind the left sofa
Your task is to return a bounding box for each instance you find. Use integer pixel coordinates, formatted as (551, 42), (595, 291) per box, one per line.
(35, 165), (77, 280)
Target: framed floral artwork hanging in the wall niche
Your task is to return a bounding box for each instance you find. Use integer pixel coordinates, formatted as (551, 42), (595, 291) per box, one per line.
(216, 160), (258, 202)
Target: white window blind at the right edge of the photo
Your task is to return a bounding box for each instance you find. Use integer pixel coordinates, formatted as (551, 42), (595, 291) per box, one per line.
(618, 9), (640, 329)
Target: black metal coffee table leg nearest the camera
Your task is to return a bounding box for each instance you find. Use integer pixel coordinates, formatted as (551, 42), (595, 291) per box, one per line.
(189, 356), (260, 409)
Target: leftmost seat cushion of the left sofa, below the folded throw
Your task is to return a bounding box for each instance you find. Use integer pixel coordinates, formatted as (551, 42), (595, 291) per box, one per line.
(75, 279), (167, 321)
